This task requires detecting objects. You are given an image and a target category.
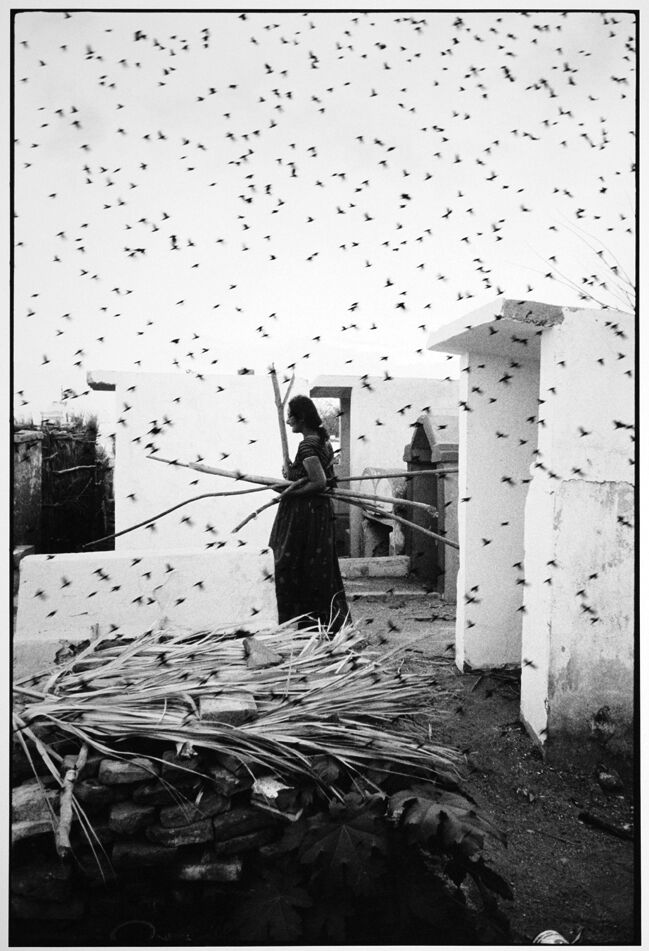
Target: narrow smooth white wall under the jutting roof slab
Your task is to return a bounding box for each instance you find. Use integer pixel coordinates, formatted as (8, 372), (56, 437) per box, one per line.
(456, 353), (539, 669)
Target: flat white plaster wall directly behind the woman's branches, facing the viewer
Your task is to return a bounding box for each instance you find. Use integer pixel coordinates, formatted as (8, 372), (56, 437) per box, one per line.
(109, 373), (308, 551)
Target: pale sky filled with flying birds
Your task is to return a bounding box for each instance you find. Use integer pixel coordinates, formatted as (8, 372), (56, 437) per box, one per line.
(13, 3), (636, 434)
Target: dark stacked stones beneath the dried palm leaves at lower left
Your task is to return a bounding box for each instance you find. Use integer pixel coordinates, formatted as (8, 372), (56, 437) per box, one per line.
(11, 751), (282, 919)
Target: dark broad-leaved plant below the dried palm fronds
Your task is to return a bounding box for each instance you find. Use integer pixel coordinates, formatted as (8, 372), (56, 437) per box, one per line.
(223, 780), (512, 944)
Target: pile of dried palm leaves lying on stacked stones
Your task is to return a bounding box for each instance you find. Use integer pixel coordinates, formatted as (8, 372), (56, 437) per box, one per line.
(14, 624), (461, 794)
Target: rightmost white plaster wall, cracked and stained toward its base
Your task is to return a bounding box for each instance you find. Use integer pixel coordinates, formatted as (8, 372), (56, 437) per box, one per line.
(521, 309), (635, 740)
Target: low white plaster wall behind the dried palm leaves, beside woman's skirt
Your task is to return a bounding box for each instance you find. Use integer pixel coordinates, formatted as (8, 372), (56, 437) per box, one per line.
(14, 549), (277, 677)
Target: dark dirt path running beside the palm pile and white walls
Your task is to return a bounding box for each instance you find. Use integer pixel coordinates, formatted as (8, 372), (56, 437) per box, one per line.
(352, 595), (638, 945)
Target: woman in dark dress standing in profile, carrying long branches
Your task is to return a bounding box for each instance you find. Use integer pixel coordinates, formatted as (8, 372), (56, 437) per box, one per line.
(269, 396), (349, 632)
